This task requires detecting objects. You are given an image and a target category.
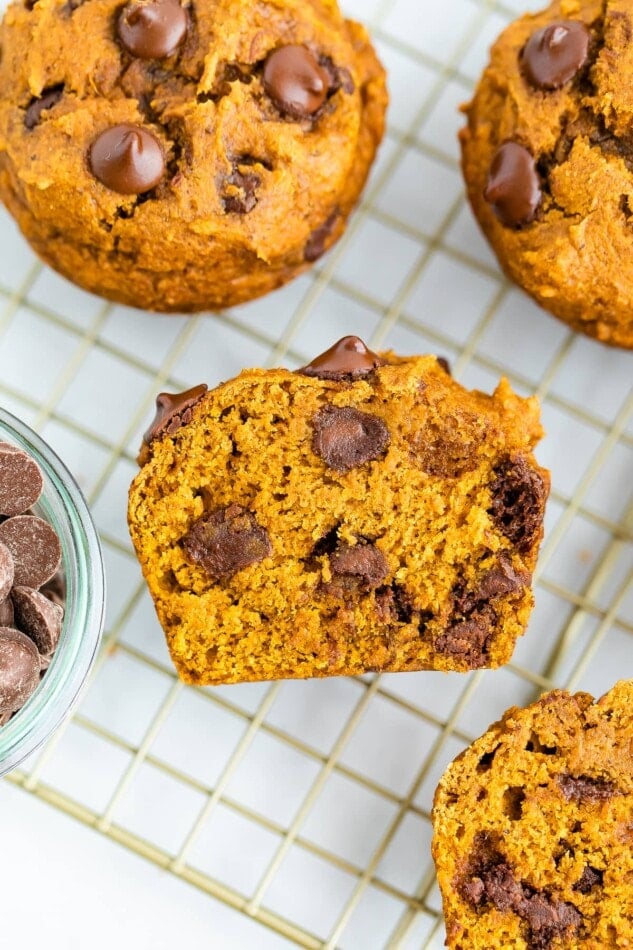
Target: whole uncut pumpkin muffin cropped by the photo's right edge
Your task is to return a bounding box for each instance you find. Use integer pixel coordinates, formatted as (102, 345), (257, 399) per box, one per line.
(461, 0), (633, 348)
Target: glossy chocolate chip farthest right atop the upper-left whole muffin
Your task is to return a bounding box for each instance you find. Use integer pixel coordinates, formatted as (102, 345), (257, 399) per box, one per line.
(264, 43), (329, 119)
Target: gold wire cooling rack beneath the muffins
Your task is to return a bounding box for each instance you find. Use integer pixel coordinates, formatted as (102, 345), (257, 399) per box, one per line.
(0, 0), (633, 950)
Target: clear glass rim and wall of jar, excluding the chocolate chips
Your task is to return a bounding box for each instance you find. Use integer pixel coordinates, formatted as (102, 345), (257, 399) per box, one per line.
(0, 409), (105, 775)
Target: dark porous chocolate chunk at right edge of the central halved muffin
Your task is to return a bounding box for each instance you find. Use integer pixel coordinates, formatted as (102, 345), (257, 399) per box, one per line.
(488, 455), (548, 554)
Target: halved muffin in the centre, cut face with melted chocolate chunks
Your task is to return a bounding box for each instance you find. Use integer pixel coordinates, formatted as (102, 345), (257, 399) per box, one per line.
(129, 337), (549, 683)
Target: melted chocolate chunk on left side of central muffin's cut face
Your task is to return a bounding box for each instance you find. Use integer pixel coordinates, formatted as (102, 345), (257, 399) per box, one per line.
(182, 505), (272, 578)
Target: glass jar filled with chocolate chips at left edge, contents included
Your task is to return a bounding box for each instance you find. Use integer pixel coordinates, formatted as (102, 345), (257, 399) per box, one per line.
(0, 409), (105, 775)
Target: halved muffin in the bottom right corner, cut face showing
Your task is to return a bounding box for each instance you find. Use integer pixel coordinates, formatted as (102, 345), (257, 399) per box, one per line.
(433, 682), (633, 950)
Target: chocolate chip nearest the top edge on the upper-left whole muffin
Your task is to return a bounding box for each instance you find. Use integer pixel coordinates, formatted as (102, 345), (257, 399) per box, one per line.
(117, 0), (187, 59)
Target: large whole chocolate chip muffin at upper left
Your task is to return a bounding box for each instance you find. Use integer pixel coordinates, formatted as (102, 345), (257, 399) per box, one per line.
(0, 0), (387, 311)
